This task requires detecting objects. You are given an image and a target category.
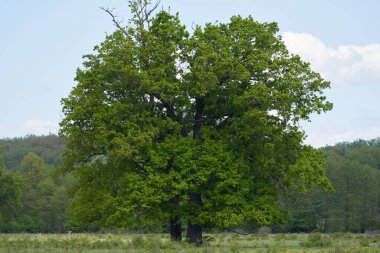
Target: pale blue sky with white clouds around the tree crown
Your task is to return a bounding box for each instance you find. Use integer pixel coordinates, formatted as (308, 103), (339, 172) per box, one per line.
(0, 0), (380, 147)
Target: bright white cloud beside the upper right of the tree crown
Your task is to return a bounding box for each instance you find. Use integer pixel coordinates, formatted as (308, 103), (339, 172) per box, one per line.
(282, 32), (380, 85)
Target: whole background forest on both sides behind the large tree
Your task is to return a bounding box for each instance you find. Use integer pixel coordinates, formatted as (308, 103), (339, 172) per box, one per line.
(0, 135), (380, 233)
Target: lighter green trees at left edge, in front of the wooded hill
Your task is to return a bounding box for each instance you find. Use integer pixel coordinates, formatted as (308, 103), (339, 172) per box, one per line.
(0, 146), (72, 232)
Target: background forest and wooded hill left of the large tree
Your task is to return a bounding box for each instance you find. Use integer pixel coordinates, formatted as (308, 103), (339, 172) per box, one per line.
(0, 135), (67, 233)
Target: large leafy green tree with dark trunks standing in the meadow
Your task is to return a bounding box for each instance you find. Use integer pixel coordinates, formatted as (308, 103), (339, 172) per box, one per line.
(60, 0), (332, 243)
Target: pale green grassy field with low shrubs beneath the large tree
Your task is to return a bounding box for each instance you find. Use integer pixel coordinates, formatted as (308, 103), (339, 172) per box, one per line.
(0, 233), (380, 253)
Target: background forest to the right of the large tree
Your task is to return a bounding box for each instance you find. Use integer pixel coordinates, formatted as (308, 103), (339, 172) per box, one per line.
(287, 139), (380, 232)
